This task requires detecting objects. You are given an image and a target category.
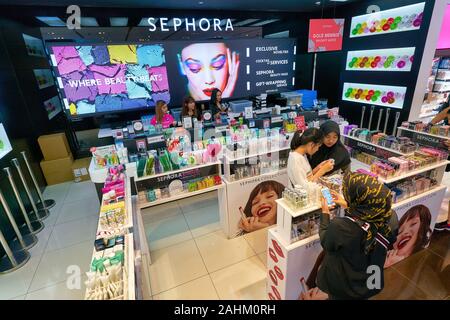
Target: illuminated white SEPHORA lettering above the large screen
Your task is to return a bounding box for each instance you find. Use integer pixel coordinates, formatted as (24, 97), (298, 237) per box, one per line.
(148, 18), (234, 32)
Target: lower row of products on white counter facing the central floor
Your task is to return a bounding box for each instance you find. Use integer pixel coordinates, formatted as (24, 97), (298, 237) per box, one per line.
(138, 175), (222, 207)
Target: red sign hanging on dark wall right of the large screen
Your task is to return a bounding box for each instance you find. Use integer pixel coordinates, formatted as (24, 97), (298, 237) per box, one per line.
(308, 19), (345, 52)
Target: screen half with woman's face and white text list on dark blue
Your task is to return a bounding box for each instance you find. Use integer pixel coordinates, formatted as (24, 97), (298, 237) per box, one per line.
(166, 39), (296, 105)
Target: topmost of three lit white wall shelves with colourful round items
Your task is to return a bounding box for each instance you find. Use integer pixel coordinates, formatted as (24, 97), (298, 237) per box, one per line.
(350, 2), (425, 38)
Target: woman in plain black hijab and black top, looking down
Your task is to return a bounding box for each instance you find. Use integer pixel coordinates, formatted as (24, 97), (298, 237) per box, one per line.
(308, 120), (350, 173)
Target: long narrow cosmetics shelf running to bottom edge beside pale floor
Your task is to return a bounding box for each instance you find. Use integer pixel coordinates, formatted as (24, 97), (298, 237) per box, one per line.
(85, 165), (134, 300)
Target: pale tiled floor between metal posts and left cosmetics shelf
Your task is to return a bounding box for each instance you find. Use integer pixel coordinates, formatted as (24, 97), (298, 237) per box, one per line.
(0, 182), (100, 300)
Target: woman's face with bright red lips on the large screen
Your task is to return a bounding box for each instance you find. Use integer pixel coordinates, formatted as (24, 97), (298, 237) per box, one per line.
(181, 43), (229, 100)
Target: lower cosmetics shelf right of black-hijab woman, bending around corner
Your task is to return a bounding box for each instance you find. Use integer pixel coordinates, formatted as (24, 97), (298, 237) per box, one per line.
(350, 148), (448, 184)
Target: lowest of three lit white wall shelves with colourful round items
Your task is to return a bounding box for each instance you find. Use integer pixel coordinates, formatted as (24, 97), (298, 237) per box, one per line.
(342, 82), (407, 109)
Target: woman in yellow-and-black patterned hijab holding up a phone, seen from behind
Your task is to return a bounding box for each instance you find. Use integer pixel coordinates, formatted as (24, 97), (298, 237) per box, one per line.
(317, 173), (396, 299)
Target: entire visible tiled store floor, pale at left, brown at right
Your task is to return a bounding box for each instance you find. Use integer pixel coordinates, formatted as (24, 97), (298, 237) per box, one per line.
(0, 177), (450, 300)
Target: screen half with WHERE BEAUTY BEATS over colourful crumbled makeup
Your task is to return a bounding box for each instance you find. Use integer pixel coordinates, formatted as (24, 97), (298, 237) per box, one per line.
(51, 44), (170, 116)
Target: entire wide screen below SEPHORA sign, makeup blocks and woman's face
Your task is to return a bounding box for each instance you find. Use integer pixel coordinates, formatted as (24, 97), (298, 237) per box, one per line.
(49, 39), (296, 117)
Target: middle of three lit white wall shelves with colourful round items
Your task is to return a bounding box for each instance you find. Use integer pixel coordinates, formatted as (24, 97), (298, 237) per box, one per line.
(346, 47), (416, 72)
